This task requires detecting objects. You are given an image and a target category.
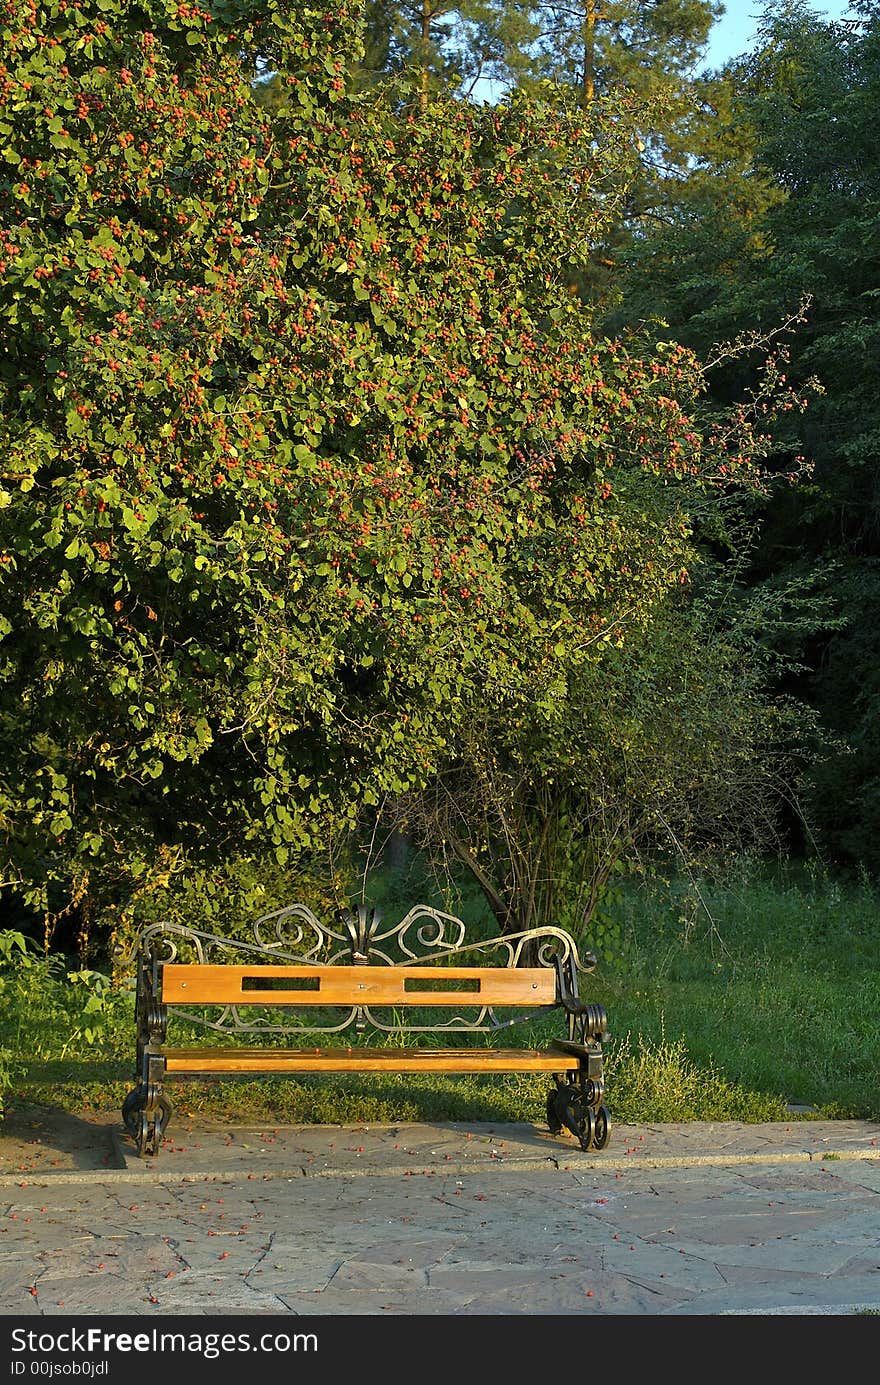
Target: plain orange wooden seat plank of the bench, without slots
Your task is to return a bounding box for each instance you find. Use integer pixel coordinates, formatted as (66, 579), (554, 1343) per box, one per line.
(164, 1047), (572, 1073)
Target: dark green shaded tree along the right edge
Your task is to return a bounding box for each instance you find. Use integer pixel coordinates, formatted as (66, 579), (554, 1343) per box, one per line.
(608, 3), (880, 870)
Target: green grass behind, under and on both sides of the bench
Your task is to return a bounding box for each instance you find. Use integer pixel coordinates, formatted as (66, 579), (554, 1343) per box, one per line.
(0, 866), (880, 1125)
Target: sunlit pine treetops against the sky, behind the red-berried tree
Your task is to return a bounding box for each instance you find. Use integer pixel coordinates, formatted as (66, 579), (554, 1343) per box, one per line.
(340, 0), (725, 303)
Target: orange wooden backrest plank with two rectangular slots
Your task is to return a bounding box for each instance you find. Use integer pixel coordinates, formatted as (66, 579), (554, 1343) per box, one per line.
(162, 963), (556, 1007)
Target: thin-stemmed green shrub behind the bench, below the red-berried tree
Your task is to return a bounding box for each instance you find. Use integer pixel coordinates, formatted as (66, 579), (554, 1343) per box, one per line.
(385, 578), (807, 956)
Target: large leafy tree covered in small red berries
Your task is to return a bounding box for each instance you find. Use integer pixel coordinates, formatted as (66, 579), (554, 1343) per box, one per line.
(0, 0), (803, 947)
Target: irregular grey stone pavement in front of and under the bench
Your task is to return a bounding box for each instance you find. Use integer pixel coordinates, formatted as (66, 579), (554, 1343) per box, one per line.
(0, 1112), (880, 1323)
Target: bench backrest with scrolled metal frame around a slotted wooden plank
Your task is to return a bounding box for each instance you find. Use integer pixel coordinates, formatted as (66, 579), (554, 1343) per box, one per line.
(127, 904), (596, 1035)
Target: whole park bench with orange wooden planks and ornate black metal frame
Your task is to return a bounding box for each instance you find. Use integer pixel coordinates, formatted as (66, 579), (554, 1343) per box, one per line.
(122, 904), (610, 1156)
